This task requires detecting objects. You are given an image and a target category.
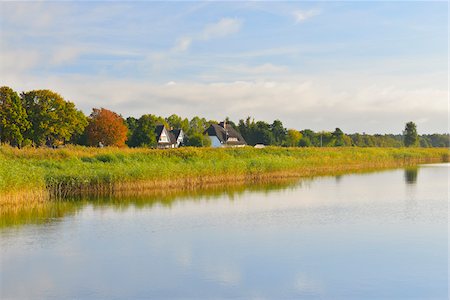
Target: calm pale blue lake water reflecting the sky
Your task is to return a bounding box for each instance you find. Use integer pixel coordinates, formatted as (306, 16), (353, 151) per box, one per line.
(0, 164), (450, 299)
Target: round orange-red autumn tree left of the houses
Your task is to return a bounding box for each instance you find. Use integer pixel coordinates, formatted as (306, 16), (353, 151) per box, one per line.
(86, 108), (128, 147)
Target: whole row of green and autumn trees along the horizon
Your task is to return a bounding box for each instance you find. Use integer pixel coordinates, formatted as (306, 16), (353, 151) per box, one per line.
(0, 87), (450, 147)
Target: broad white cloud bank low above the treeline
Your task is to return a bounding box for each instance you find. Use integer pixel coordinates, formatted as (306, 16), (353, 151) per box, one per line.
(3, 71), (448, 133)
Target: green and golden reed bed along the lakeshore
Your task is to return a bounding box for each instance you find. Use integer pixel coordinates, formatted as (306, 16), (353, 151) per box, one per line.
(0, 146), (450, 205)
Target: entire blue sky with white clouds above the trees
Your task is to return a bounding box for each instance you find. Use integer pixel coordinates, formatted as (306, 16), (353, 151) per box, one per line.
(0, 1), (449, 133)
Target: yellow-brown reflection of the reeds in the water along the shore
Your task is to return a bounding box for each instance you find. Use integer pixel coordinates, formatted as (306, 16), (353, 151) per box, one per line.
(0, 167), (430, 227)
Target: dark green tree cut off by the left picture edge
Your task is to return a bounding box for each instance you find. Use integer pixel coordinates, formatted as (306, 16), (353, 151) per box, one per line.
(0, 86), (31, 147)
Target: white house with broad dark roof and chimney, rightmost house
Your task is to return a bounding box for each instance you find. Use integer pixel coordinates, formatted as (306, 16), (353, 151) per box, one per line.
(204, 122), (247, 148)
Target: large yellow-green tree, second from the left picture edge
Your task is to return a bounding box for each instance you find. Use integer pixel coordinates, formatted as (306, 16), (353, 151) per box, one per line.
(21, 90), (87, 146)
